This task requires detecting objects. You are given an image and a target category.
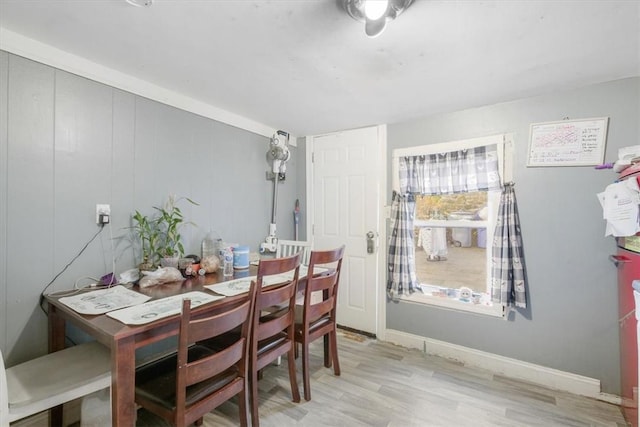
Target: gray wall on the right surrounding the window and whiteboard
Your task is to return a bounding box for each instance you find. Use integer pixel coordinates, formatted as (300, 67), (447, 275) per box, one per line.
(387, 78), (640, 394)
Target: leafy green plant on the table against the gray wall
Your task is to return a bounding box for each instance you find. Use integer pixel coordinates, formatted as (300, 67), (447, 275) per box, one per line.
(132, 195), (198, 268)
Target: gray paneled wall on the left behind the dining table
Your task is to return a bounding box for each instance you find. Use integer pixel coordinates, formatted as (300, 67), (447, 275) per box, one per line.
(0, 51), (304, 366)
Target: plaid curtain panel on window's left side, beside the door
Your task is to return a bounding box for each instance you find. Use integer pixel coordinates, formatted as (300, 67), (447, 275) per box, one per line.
(387, 191), (420, 298)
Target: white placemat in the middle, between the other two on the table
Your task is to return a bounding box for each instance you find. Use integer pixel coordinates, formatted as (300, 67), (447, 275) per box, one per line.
(107, 291), (224, 325)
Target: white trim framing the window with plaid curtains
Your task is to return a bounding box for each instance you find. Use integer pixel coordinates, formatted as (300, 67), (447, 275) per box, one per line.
(391, 134), (513, 317)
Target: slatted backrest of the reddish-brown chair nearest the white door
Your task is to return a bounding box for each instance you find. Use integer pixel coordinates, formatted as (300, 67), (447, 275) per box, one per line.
(302, 245), (344, 325)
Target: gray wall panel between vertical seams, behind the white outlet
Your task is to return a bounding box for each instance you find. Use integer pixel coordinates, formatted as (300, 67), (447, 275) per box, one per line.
(52, 71), (113, 289)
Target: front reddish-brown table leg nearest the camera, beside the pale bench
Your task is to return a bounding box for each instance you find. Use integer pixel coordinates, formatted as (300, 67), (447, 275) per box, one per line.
(111, 337), (136, 427)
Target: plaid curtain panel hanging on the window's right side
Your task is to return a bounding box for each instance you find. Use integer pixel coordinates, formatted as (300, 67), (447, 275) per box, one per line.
(491, 183), (527, 308)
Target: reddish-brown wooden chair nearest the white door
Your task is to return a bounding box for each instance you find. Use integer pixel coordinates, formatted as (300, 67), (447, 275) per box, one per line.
(295, 246), (344, 400)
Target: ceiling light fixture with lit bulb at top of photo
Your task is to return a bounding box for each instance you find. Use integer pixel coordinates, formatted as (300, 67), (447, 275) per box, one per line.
(339, 0), (413, 37)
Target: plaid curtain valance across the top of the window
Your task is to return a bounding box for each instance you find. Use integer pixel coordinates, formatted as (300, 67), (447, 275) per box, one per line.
(399, 144), (500, 195)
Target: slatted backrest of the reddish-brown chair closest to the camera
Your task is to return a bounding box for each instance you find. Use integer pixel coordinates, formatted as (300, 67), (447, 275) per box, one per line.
(176, 282), (257, 425)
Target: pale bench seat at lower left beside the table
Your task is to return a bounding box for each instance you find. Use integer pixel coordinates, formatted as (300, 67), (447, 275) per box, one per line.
(0, 341), (111, 427)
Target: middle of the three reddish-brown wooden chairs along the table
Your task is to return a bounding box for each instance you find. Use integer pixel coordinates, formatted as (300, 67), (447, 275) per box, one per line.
(249, 253), (301, 427)
